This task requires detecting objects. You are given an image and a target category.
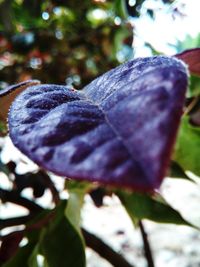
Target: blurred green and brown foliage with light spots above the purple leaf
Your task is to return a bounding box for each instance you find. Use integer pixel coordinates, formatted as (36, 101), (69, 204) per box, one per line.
(0, 0), (177, 88)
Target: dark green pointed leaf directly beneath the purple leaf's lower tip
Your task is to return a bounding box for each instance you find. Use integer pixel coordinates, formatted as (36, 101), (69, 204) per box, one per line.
(118, 192), (191, 226)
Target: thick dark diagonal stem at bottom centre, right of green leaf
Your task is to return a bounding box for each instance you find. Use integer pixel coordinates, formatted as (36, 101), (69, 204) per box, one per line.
(82, 229), (134, 267)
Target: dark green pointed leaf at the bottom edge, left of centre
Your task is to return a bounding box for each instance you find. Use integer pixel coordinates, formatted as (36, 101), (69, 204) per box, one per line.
(40, 201), (85, 267)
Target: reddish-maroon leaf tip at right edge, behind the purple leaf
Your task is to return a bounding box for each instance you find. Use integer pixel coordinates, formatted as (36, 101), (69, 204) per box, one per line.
(175, 48), (200, 76)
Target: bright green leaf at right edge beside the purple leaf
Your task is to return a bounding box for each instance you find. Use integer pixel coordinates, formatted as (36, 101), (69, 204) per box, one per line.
(174, 117), (200, 176)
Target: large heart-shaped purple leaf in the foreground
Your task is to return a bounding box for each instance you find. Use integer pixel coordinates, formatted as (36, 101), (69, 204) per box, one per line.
(9, 56), (187, 191)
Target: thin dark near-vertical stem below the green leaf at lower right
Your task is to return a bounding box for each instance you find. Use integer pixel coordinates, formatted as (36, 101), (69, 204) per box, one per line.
(139, 221), (155, 267)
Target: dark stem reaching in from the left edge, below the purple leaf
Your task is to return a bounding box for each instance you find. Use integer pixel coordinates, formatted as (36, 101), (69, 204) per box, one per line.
(0, 188), (43, 212)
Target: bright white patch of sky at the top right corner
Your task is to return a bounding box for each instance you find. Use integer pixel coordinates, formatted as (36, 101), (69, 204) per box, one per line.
(132, 0), (200, 57)
